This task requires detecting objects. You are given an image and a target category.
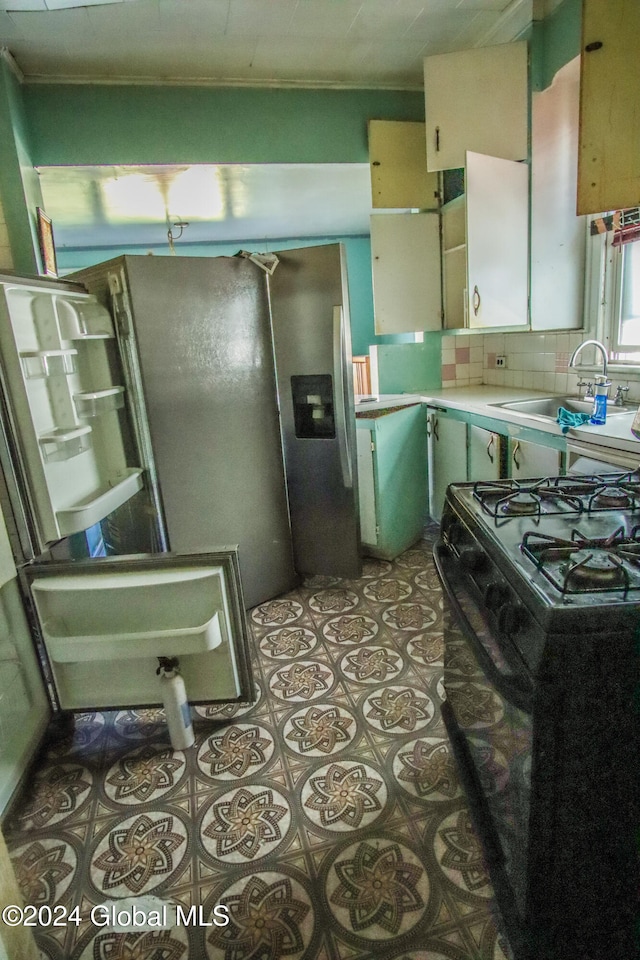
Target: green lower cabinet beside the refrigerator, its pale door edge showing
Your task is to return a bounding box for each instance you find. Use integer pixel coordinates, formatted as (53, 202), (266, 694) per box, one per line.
(356, 404), (427, 560)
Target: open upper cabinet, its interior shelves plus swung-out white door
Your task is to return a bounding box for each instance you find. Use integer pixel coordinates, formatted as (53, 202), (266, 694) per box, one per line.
(442, 152), (529, 329)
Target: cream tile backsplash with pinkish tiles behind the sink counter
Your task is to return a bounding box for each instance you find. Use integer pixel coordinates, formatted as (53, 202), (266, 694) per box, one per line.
(442, 331), (640, 401)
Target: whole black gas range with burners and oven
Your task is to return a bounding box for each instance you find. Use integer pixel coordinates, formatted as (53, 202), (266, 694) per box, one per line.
(435, 472), (640, 960)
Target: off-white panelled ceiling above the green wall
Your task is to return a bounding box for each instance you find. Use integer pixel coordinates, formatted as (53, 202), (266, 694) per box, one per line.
(0, 0), (558, 89)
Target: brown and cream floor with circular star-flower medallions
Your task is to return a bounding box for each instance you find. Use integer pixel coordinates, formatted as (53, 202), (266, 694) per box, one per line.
(5, 539), (508, 960)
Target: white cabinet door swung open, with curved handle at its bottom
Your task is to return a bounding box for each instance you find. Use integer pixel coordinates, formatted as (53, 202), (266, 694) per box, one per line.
(466, 152), (529, 328)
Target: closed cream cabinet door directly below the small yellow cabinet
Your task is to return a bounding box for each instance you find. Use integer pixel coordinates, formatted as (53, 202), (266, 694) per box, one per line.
(371, 213), (442, 334)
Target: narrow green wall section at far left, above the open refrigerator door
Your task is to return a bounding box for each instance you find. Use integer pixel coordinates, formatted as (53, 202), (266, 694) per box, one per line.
(0, 58), (42, 274)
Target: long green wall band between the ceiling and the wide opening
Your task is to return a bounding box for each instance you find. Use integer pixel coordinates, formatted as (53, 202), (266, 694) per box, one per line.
(24, 84), (424, 165)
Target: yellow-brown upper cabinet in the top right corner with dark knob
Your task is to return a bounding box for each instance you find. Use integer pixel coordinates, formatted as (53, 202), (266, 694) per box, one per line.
(577, 0), (640, 214)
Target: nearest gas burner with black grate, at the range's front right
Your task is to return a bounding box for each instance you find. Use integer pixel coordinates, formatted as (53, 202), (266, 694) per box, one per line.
(520, 527), (640, 597)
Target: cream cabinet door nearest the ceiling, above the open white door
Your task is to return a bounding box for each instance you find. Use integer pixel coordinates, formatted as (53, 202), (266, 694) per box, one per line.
(424, 41), (528, 170)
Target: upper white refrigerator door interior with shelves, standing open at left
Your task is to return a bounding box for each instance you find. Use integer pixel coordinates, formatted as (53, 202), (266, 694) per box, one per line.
(0, 277), (142, 557)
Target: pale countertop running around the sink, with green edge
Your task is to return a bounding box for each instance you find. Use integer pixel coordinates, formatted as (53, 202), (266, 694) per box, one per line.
(356, 384), (640, 460)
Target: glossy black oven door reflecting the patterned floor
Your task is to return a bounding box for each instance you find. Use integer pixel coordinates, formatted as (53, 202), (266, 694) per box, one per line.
(434, 543), (533, 957)
